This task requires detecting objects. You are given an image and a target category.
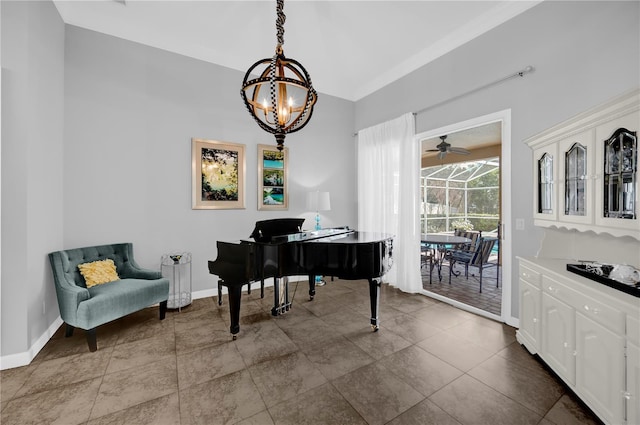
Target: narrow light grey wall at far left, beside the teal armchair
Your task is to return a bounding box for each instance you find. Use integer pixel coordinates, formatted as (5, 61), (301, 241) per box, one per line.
(0, 1), (64, 360)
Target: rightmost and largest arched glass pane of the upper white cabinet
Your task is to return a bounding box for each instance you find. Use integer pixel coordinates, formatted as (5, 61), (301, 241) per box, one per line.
(603, 128), (638, 219)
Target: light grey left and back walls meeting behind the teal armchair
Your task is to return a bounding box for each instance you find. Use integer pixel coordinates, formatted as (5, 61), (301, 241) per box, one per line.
(1, 1), (356, 368)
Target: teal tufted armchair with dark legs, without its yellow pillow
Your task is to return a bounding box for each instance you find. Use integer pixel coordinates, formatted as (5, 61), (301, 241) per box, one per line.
(49, 243), (169, 351)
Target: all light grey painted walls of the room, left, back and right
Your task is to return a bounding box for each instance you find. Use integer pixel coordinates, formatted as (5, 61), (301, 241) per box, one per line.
(0, 1), (640, 359)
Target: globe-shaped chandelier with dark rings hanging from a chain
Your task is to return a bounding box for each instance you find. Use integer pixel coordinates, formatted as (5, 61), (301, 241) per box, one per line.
(240, 0), (318, 150)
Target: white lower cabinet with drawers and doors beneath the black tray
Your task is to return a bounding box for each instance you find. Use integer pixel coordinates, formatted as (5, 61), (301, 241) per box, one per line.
(516, 258), (640, 425)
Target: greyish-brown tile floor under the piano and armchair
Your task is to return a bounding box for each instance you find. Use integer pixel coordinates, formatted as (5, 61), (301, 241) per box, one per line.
(0, 281), (598, 425)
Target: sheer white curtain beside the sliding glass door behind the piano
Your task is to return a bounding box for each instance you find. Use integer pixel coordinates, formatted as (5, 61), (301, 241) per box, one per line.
(358, 113), (422, 293)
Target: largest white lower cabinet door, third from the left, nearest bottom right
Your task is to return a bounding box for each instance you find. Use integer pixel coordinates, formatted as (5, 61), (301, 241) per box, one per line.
(576, 313), (625, 424)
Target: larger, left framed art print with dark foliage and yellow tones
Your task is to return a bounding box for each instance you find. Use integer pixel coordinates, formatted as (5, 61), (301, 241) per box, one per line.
(191, 139), (245, 210)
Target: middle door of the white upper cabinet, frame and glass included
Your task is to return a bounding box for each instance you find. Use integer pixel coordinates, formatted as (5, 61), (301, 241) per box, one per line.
(558, 129), (596, 224)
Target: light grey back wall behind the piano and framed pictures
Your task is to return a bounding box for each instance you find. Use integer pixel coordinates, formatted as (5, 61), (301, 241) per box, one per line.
(63, 26), (356, 291)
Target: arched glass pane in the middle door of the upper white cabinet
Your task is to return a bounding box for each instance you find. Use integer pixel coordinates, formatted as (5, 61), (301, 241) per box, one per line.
(564, 143), (587, 215)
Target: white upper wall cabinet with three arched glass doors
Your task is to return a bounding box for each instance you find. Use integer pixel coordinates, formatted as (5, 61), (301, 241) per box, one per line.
(525, 90), (640, 240)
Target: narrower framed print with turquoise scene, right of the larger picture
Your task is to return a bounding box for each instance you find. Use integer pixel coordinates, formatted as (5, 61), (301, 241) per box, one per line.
(258, 145), (289, 210)
